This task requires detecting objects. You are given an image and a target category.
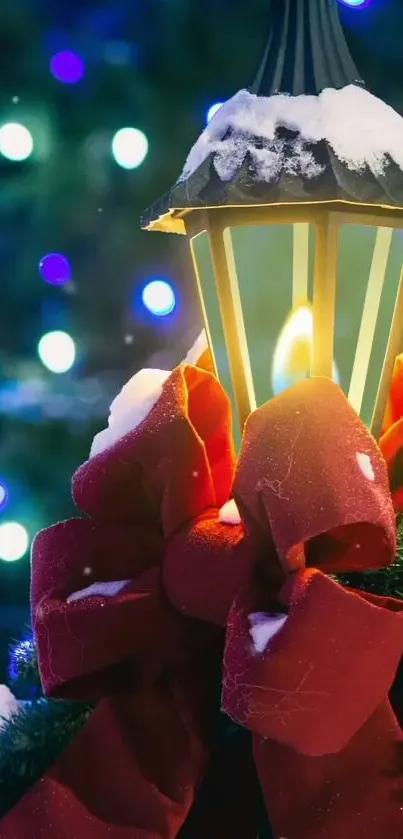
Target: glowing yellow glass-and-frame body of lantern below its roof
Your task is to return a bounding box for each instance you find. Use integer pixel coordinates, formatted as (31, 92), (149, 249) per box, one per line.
(191, 205), (403, 440)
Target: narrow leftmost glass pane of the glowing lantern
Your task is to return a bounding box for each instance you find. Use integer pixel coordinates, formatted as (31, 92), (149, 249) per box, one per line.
(190, 226), (241, 443)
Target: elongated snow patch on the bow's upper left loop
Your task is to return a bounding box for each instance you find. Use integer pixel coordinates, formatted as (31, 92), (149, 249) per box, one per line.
(90, 369), (171, 457)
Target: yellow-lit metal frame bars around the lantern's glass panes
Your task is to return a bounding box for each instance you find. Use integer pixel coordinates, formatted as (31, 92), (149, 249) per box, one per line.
(181, 201), (403, 437)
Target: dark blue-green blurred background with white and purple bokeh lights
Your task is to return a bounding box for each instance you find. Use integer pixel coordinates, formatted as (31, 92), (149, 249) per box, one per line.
(0, 0), (403, 681)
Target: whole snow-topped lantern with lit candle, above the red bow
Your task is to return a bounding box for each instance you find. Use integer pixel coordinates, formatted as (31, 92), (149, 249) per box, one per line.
(142, 0), (403, 436)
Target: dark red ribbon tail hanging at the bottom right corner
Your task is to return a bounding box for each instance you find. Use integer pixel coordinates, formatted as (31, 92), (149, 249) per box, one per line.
(254, 700), (403, 839)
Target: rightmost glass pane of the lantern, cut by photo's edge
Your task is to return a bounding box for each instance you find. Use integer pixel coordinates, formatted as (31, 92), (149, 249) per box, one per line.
(334, 224), (403, 426)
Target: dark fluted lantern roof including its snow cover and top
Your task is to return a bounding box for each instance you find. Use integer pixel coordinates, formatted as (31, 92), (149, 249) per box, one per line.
(142, 0), (403, 233)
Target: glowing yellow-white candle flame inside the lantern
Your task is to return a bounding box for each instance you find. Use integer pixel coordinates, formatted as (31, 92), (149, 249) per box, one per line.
(271, 303), (338, 395)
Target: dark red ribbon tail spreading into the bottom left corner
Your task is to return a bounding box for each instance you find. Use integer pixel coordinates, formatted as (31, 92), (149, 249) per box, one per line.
(0, 661), (218, 839)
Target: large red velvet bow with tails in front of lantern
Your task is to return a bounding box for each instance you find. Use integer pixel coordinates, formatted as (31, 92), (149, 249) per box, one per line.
(1, 366), (403, 839)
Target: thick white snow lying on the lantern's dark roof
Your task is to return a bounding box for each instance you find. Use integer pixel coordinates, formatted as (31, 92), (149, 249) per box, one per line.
(179, 85), (403, 183)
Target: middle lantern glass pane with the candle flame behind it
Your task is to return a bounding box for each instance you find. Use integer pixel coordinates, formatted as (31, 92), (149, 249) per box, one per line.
(230, 224), (315, 405)
